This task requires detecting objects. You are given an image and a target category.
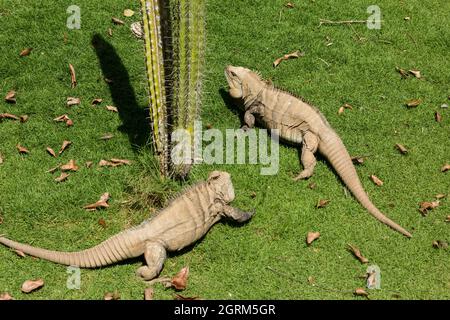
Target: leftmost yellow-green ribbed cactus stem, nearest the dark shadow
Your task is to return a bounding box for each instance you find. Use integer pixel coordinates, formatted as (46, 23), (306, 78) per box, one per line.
(141, 0), (169, 176)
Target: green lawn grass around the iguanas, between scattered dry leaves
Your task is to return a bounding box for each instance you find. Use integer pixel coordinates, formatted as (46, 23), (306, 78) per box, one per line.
(0, 0), (450, 299)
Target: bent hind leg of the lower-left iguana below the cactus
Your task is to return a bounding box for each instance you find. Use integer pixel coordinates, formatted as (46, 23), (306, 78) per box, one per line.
(136, 242), (166, 280)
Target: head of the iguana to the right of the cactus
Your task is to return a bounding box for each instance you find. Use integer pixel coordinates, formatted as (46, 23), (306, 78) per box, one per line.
(225, 66), (265, 99)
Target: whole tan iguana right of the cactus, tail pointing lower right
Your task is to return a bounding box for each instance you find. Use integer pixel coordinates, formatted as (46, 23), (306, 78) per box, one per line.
(225, 66), (411, 237)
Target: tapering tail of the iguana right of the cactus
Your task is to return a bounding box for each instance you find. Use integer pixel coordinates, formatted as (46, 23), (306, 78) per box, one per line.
(319, 132), (411, 238)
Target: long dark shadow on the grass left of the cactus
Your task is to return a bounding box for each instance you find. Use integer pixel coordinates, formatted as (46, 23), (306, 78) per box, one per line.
(91, 34), (151, 151)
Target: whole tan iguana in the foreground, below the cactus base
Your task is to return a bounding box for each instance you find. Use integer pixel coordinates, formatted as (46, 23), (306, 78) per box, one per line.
(0, 171), (254, 280)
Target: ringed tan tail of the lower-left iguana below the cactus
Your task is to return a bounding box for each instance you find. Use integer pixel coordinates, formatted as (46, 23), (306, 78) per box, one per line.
(0, 230), (141, 268)
